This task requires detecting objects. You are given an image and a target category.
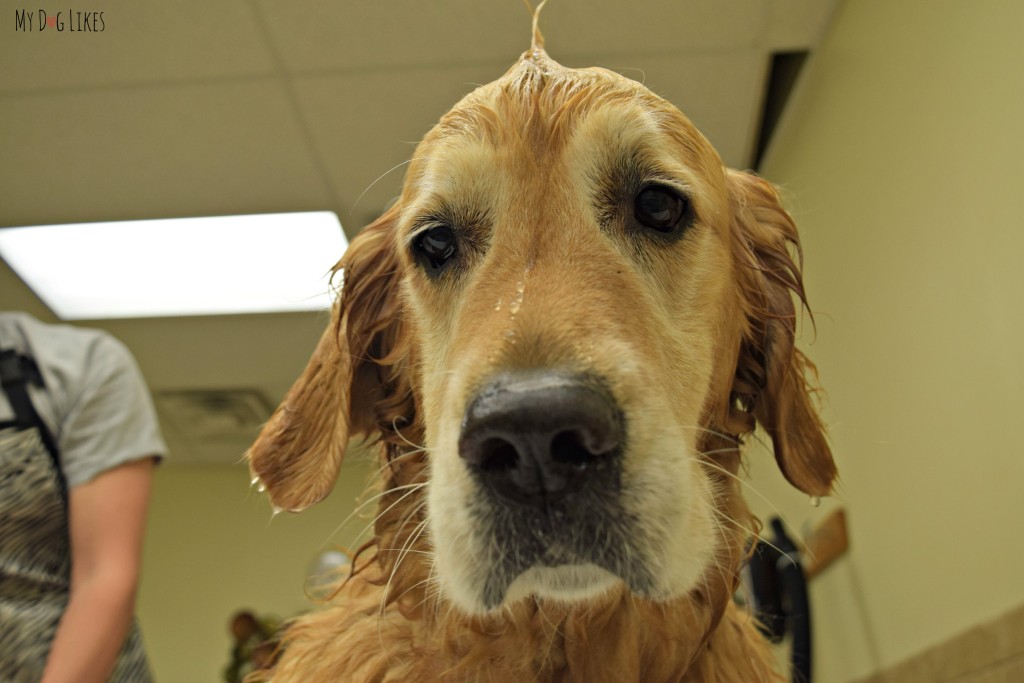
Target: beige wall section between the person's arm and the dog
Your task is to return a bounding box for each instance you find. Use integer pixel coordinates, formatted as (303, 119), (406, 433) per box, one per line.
(138, 458), (376, 683)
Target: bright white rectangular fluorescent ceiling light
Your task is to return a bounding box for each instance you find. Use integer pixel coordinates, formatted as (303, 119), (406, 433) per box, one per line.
(0, 211), (346, 321)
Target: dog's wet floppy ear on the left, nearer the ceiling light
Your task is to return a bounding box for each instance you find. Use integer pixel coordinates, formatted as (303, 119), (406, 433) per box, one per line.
(247, 207), (414, 511)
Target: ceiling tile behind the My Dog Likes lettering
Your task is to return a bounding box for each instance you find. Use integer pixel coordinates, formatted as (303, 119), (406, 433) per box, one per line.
(0, 0), (273, 93)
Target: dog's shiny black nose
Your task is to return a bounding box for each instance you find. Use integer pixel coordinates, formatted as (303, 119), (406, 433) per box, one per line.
(459, 371), (624, 506)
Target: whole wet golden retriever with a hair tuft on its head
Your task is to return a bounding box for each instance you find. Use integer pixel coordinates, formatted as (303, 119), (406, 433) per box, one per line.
(249, 22), (836, 683)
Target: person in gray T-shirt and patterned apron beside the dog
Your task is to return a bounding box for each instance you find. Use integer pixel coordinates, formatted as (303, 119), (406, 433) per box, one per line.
(0, 311), (167, 683)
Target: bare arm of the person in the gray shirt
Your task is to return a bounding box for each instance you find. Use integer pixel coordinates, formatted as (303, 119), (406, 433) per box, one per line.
(43, 458), (154, 683)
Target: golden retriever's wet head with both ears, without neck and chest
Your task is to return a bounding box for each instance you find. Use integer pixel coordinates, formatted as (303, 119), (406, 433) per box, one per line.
(250, 50), (835, 612)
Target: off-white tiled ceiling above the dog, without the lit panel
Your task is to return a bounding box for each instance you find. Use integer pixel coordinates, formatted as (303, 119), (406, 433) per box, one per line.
(0, 0), (838, 462)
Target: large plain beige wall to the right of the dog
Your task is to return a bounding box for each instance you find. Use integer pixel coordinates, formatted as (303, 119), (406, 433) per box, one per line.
(752, 0), (1024, 683)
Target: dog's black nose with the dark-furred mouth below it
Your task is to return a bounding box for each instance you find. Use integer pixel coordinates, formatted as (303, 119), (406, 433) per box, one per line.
(459, 370), (652, 608)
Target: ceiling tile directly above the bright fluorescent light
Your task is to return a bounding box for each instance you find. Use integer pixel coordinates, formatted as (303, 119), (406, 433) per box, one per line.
(0, 80), (332, 226)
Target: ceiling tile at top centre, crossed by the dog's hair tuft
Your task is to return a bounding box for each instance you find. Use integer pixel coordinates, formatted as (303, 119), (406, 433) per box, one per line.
(256, 0), (770, 73)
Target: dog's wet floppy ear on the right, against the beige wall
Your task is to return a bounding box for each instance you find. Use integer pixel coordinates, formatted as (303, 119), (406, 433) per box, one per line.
(728, 171), (836, 496)
